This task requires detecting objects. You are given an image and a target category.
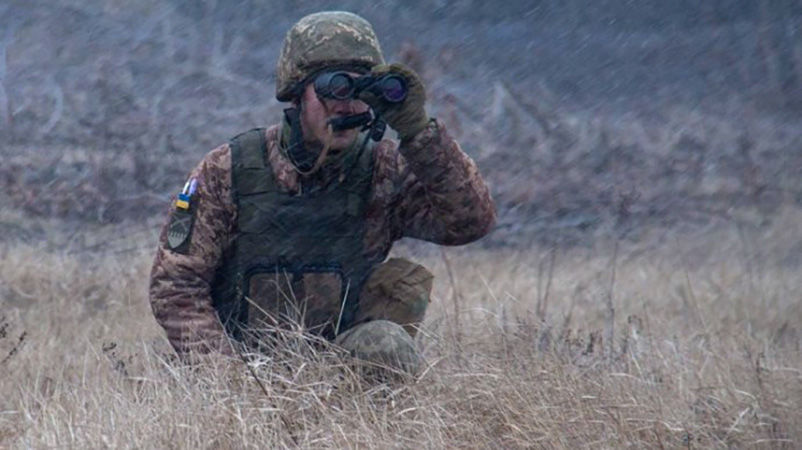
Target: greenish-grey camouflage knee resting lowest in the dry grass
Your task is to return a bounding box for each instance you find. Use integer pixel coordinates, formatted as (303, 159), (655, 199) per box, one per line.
(334, 320), (423, 375)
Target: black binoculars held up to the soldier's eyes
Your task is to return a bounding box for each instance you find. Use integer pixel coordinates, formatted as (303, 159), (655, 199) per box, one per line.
(314, 71), (407, 103)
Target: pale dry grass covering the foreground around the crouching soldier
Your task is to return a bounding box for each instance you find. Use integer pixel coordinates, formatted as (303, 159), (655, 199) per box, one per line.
(0, 211), (802, 448)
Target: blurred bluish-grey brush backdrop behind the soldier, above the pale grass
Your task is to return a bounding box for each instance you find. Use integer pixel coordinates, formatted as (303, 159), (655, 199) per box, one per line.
(0, 0), (802, 246)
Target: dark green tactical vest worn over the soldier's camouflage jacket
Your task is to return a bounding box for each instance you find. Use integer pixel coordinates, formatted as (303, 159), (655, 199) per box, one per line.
(212, 128), (386, 340)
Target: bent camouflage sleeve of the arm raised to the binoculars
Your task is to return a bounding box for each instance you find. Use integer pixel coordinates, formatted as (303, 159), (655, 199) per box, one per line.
(395, 120), (496, 245)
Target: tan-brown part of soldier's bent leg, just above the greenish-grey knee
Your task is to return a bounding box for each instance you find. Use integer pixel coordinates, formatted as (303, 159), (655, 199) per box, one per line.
(353, 258), (434, 337)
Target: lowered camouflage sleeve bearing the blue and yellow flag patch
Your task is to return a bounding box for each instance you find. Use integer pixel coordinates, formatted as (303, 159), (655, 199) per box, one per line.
(150, 145), (236, 355)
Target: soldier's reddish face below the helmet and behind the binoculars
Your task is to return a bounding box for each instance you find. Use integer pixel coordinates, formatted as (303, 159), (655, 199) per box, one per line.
(301, 78), (368, 150)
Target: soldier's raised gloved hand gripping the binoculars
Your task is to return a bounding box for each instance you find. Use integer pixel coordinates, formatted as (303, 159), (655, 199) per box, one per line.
(359, 63), (429, 140)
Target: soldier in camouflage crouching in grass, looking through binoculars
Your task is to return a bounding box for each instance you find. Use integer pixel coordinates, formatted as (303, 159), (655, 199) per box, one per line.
(150, 12), (495, 373)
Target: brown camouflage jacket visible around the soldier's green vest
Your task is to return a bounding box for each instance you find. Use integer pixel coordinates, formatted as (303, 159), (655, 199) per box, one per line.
(150, 121), (495, 354)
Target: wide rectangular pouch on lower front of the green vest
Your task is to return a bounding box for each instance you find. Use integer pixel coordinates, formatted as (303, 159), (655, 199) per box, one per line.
(245, 269), (348, 337)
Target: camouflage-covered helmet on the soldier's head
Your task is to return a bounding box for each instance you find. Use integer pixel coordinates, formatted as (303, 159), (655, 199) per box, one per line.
(276, 11), (384, 102)
